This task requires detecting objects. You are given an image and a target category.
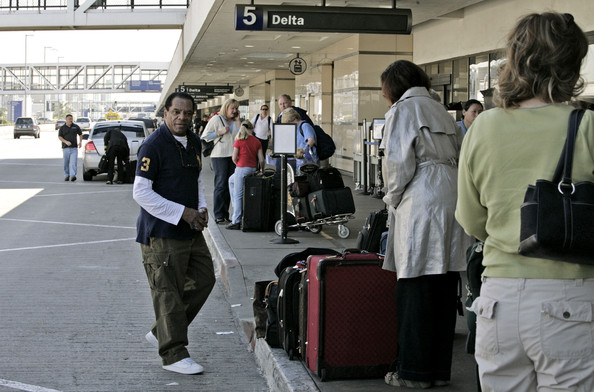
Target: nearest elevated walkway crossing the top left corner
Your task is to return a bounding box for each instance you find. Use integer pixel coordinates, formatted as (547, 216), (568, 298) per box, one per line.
(0, 0), (190, 31)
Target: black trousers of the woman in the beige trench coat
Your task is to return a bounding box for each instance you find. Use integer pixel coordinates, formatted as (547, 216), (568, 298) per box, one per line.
(396, 272), (460, 381)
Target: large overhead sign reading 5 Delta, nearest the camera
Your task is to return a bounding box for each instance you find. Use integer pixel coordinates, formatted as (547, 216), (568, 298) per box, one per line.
(235, 4), (412, 34)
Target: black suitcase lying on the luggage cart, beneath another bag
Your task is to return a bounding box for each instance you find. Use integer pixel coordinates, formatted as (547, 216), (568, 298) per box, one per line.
(308, 187), (355, 219)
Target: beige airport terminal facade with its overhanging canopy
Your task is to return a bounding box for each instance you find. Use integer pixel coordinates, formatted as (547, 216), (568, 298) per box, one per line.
(162, 0), (594, 171)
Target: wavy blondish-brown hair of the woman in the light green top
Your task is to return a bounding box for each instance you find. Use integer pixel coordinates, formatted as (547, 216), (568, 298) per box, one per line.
(495, 12), (588, 108)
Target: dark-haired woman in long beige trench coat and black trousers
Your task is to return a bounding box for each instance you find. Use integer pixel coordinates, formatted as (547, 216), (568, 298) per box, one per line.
(381, 60), (472, 388)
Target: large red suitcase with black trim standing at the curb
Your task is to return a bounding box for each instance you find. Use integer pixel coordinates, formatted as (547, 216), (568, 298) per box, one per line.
(305, 253), (396, 381)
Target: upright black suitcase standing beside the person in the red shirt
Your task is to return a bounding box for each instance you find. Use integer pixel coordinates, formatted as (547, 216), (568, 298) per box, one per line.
(241, 175), (274, 231)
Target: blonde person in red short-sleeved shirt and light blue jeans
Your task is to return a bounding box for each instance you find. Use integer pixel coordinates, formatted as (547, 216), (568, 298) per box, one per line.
(226, 120), (266, 230)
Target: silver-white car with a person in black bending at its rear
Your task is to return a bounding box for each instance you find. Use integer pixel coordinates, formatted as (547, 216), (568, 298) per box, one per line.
(83, 120), (149, 181)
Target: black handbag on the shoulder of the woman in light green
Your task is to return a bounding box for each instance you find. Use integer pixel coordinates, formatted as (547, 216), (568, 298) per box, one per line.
(518, 109), (594, 265)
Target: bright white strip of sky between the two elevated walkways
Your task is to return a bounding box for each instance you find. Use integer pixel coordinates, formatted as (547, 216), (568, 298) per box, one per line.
(0, 30), (181, 65)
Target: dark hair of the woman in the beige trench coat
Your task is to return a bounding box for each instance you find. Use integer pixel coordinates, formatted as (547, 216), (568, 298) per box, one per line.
(380, 60), (431, 103)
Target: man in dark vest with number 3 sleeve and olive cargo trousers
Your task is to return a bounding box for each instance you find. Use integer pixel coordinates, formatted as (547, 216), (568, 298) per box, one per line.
(133, 92), (215, 374)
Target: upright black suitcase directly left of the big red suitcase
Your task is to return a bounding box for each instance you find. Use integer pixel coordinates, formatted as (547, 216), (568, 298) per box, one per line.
(277, 267), (301, 360)
